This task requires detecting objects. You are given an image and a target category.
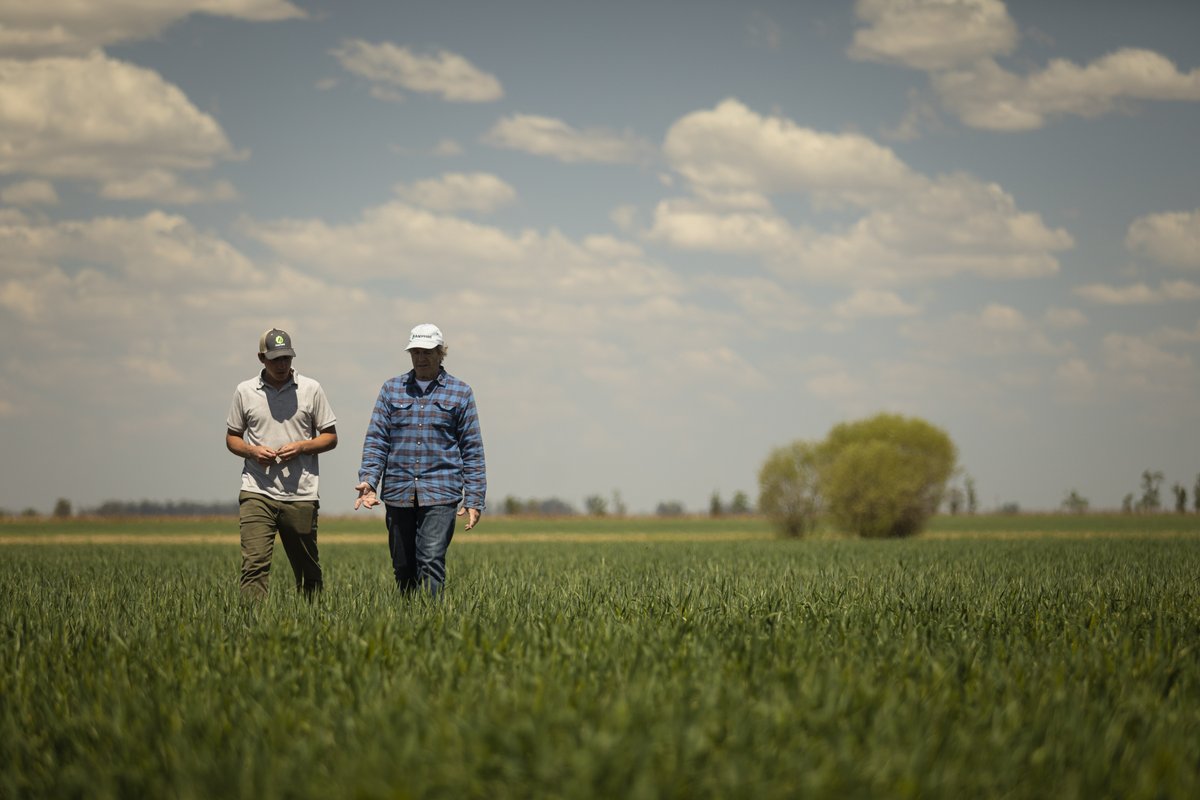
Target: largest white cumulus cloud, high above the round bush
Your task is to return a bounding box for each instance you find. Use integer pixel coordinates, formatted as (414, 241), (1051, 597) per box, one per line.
(647, 100), (1074, 285)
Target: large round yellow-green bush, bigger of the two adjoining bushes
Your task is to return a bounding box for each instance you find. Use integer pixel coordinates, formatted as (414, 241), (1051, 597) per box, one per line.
(817, 414), (958, 537)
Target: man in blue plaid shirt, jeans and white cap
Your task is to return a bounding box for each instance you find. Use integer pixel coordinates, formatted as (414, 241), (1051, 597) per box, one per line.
(354, 324), (487, 596)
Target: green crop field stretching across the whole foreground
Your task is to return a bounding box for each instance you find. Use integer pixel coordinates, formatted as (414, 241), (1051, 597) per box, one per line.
(0, 515), (1200, 799)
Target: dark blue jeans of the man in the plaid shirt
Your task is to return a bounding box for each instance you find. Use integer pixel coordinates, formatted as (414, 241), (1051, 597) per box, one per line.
(386, 504), (457, 597)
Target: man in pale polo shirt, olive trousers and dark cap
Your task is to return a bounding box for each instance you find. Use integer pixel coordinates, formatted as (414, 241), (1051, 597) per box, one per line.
(226, 329), (337, 599)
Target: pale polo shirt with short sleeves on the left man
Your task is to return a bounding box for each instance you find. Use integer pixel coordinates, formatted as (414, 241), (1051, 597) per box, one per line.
(226, 371), (337, 501)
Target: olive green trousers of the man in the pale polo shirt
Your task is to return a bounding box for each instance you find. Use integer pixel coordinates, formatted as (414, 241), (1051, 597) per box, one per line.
(238, 492), (320, 597)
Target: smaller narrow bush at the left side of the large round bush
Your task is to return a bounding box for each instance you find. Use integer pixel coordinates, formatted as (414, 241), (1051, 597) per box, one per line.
(758, 441), (821, 536)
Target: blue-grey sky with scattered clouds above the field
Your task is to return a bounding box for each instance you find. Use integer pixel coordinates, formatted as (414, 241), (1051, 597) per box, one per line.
(0, 0), (1200, 513)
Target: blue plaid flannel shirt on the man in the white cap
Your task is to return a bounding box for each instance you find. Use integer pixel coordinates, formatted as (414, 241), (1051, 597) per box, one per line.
(359, 369), (487, 511)
